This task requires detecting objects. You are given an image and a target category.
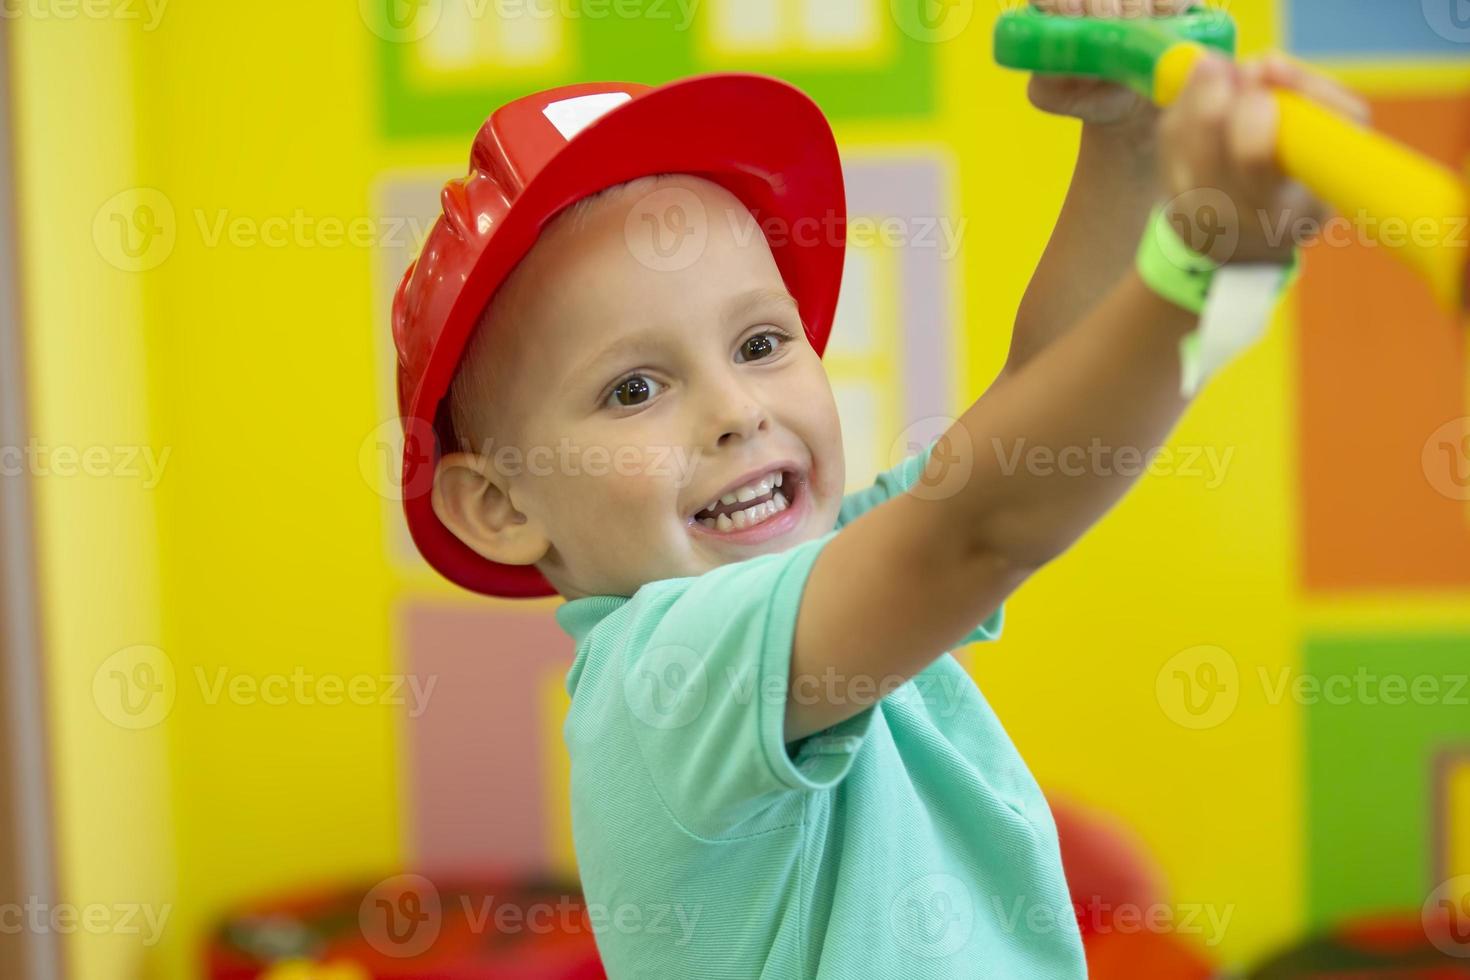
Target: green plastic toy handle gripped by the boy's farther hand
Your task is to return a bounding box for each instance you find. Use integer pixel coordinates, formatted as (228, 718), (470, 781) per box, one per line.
(995, 4), (1235, 98)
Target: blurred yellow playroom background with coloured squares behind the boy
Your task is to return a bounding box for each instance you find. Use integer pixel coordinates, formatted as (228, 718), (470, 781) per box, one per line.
(0, 0), (1470, 980)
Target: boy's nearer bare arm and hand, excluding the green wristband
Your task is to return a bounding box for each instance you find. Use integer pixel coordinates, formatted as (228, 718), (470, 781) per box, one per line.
(786, 51), (1346, 742)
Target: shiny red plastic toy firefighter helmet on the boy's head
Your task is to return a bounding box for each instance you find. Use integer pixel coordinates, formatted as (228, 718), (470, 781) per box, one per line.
(392, 73), (847, 597)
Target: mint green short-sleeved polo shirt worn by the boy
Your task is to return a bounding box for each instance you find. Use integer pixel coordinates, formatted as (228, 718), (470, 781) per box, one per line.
(556, 444), (1086, 980)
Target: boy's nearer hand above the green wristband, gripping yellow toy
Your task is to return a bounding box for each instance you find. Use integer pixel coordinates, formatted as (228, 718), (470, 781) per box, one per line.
(1158, 54), (1369, 263)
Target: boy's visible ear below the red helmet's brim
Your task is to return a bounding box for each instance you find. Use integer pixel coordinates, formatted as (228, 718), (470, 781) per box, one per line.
(432, 453), (551, 564)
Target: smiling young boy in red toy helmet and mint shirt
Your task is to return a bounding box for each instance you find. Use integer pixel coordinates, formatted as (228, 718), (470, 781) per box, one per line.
(394, 0), (1361, 980)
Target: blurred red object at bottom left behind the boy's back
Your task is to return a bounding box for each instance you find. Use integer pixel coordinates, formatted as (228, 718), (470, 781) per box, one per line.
(206, 874), (606, 980)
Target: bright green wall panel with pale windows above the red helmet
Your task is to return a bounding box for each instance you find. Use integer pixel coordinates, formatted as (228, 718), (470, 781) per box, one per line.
(373, 0), (934, 140)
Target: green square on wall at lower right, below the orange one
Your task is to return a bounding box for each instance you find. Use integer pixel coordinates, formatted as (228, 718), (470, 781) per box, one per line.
(1311, 633), (1470, 926)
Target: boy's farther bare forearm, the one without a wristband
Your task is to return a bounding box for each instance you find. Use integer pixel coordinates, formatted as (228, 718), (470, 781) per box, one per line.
(1005, 120), (1163, 373)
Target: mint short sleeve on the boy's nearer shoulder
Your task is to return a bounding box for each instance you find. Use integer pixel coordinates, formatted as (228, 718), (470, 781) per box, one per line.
(622, 532), (873, 836)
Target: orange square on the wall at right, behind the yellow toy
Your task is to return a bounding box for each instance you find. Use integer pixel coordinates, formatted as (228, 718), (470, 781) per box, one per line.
(1297, 96), (1470, 594)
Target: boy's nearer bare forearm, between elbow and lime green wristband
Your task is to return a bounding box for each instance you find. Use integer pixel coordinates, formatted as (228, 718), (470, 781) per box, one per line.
(923, 270), (1198, 567)
